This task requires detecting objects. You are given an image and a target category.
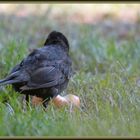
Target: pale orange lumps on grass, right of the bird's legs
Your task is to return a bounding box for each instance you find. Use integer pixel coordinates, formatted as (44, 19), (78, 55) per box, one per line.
(52, 94), (80, 108)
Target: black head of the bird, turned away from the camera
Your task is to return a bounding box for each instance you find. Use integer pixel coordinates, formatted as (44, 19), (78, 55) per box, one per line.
(44, 31), (69, 51)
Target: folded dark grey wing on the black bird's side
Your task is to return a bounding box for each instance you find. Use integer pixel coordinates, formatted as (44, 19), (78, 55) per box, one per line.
(21, 66), (65, 90)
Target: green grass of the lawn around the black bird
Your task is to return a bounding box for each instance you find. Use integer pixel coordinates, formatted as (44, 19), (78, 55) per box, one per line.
(0, 4), (140, 137)
